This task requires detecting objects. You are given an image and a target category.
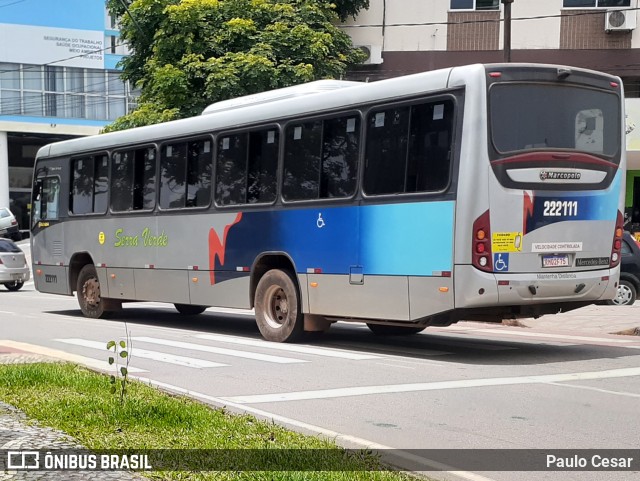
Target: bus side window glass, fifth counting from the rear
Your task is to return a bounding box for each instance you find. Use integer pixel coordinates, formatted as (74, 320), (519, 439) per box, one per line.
(111, 147), (156, 212)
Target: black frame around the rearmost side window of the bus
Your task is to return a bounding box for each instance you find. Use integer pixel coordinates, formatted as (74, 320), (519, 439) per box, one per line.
(360, 93), (464, 203)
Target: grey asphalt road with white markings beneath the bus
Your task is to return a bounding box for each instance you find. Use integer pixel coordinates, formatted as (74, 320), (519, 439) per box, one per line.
(0, 244), (640, 481)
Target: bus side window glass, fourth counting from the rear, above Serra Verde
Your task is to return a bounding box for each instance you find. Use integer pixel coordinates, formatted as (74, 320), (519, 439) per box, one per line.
(160, 139), (213, 209)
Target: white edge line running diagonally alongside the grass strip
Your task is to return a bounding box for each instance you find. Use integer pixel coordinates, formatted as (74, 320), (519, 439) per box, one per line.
(132, 376), (494, 481)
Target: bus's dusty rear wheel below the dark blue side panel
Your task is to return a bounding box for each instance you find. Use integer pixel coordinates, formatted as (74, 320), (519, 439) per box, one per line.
(255, 269), (304, 342)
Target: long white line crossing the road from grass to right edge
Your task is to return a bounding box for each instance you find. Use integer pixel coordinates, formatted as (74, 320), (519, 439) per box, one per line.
(222, 367), (640, 404)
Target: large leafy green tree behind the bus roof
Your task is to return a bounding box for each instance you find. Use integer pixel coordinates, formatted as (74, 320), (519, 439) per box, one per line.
(105, 0), (368, 131)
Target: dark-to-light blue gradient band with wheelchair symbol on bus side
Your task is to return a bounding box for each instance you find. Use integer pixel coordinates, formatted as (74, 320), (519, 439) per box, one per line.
(224, 201), (455, 276)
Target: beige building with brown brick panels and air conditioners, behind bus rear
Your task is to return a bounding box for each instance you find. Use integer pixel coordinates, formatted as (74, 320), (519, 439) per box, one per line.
(343, 0), (640, 225)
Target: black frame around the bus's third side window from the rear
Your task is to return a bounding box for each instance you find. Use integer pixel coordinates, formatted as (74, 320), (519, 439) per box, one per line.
(211, 122), (284, 210)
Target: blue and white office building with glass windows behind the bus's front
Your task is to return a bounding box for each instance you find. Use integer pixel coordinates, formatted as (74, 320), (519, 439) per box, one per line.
(0, 0), (132, 229)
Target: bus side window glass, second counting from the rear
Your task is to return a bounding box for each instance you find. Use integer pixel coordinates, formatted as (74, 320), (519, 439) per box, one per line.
(282, 114), (360, 200)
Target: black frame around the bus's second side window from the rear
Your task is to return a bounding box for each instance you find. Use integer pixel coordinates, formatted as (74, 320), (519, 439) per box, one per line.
(278, 109), (367, 206)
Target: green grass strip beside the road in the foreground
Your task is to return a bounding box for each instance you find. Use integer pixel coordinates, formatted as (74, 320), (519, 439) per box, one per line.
(0, 363), (424, 481)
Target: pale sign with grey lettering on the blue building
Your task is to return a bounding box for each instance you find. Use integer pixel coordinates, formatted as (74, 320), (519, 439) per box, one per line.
(0, 24), (104, 69)
